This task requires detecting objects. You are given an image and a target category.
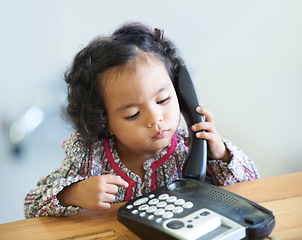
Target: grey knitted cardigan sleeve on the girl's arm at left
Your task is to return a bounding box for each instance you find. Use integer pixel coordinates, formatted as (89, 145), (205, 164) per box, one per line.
(24, 133), (89, 218)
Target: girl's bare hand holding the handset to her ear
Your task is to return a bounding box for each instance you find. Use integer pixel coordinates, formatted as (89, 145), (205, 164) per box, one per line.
(192, 107), (231, 163)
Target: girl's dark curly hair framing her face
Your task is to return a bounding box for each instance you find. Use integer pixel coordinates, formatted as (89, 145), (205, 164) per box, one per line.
(65, 22), (183, 143)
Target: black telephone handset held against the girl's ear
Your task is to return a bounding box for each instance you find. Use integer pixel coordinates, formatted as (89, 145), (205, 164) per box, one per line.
(175, 65), (207, 181)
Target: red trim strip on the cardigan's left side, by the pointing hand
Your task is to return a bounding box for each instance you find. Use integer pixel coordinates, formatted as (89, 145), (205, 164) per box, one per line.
(103, 139), (135, 201)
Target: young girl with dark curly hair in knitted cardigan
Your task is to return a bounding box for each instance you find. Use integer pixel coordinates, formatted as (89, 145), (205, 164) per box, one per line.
(25, 23), (259, 218)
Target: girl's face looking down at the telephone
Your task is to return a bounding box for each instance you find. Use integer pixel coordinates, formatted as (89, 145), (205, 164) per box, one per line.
(102, 58), (180, 158)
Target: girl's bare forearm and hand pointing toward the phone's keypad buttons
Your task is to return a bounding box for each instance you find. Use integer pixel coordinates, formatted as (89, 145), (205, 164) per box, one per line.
(57, 174), (129, 210)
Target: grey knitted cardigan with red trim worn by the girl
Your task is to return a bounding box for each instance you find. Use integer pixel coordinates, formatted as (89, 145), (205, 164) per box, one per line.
(24, 128), (259, 218)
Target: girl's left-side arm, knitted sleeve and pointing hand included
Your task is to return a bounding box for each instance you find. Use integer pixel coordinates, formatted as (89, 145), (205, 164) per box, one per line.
(24, 133), (128, 218)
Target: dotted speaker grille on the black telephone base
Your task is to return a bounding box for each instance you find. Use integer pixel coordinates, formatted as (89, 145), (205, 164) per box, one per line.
(200, 189), (239, 210)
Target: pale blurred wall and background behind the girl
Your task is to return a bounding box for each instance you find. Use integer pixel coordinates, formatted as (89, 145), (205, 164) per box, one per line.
(0, 0), (302, 223)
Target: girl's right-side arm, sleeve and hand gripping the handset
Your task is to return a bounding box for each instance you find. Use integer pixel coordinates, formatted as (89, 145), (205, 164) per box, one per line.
(192, 107), (260, 185)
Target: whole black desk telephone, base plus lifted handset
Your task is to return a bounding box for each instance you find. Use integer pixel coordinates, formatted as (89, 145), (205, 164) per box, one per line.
(118, 66), (275, 240)
